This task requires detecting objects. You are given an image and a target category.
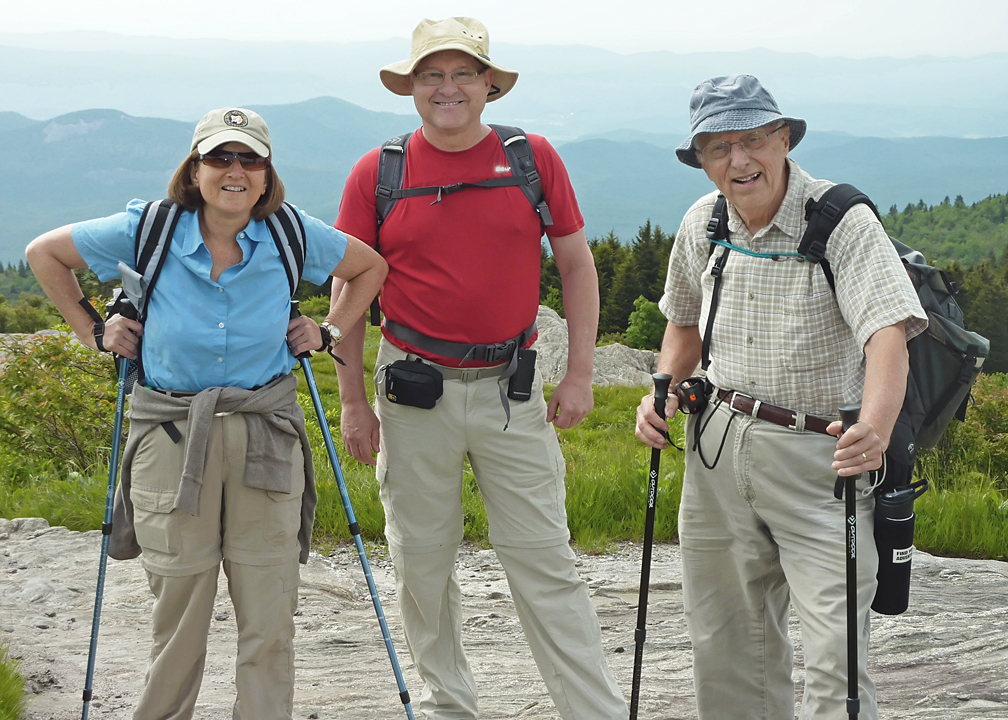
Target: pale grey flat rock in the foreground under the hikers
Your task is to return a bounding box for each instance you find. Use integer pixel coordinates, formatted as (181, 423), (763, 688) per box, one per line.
(0, 518), (1008, 720)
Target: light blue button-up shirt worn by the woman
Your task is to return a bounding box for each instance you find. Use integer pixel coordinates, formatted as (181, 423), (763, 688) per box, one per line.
(73, 200), (347, 392)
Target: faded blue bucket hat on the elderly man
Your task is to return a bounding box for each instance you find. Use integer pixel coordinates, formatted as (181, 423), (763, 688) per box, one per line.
(675, 75), (806, 168)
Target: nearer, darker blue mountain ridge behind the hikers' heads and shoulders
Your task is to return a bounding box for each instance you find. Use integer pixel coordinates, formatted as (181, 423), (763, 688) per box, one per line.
(0, 98), (1008, 265)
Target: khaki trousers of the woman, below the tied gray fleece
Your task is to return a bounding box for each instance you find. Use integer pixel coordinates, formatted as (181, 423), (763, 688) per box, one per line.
(130, 414), (304, 720)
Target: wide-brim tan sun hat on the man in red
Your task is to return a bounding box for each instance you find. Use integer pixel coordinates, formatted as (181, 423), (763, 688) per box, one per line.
(380, 17), (518, 103)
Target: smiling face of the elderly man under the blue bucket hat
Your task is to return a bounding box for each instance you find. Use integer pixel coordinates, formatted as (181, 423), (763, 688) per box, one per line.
(696, 124), (790, 234)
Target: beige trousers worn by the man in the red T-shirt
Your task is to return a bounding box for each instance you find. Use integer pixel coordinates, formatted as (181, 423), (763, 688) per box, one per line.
(376, 340), (628, 720)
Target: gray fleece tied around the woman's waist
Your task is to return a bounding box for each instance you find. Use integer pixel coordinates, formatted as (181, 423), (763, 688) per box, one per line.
(109, 374), (318, 564)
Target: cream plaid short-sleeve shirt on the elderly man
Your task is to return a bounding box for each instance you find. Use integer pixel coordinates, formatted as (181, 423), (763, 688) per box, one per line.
(659, 158), (927, 417)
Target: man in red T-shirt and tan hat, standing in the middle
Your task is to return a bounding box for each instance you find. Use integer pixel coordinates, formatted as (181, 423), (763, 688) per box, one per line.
(333, 18), (628, 720)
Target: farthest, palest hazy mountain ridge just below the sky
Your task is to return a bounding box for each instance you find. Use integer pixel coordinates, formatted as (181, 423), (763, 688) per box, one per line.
(0, 32), (1008, 140)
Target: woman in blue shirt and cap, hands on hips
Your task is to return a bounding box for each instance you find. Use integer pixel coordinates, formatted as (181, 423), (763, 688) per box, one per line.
(27, 108), (387, 720)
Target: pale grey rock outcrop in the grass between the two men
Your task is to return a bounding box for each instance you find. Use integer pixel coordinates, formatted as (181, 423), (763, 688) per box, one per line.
(532, 305), (658, 385)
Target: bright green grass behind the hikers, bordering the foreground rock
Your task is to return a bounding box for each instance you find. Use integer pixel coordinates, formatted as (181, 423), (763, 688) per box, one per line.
(0, 320), (1008, 559)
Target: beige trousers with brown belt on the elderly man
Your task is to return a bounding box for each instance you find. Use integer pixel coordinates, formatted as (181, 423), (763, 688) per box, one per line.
(679, 399), (878, 720)
